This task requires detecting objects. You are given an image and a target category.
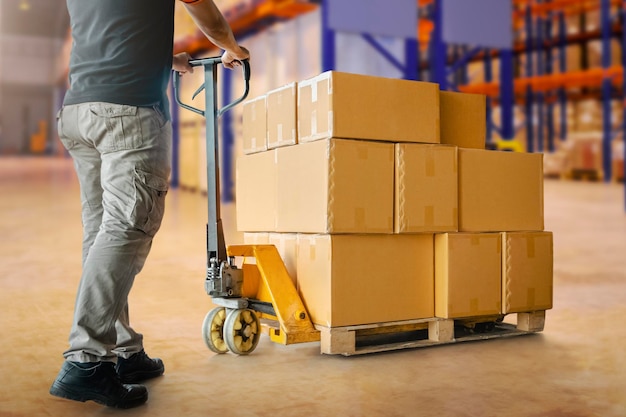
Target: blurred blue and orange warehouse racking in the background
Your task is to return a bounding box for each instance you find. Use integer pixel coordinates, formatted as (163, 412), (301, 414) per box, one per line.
(169, 0), (626, 208)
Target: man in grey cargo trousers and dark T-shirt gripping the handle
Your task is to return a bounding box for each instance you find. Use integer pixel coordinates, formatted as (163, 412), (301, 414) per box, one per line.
(50, 0), (249, 408)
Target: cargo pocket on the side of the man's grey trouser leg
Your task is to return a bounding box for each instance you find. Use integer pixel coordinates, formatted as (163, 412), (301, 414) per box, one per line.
(131, 168), (168, 236)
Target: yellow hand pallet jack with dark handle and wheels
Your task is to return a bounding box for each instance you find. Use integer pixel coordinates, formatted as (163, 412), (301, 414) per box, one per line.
(174, 57), (320, 355)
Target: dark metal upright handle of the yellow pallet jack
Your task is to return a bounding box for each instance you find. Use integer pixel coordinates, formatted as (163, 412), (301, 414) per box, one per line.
(173, 57), (250, 265)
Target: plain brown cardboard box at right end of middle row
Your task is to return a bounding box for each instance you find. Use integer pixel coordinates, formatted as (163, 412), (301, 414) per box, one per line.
(459, 148), (544, 232)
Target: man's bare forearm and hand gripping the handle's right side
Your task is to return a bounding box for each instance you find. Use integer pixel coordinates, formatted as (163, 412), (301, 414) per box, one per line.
(179, 0), (250, 68)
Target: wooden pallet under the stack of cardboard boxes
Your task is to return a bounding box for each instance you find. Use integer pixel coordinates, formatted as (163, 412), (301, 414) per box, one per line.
(316, 311), (545, 356)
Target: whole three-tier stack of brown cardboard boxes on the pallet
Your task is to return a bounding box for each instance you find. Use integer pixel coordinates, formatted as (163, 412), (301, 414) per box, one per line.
(236, 72), (552, 327)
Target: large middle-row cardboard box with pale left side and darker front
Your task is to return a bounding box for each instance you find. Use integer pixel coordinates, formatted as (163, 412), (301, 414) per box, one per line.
(275, 139), (394, 233)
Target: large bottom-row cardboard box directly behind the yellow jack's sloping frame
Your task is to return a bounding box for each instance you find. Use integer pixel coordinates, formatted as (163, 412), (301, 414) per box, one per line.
(298, 234), (434, 327)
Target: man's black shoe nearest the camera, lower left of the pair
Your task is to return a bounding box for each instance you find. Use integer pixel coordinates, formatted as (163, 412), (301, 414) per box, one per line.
(50, 361), (148, 408)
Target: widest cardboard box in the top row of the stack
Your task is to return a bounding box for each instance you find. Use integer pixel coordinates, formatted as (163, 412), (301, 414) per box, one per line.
(298, 71), (439, 143)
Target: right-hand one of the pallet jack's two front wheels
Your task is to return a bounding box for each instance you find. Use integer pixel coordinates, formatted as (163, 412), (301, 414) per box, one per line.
(224, 309), (261, 355)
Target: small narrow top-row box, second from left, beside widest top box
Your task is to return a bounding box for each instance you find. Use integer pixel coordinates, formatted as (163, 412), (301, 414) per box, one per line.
(267, 82), (298, 149)
